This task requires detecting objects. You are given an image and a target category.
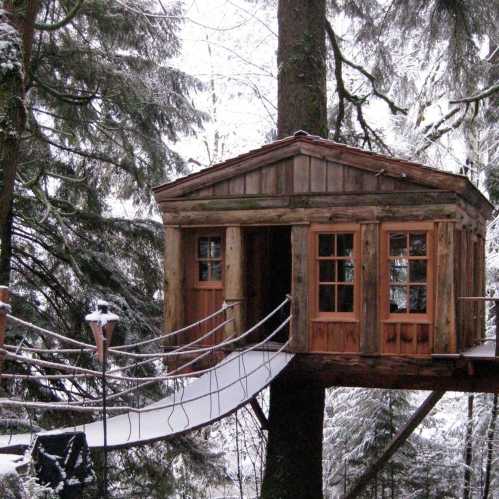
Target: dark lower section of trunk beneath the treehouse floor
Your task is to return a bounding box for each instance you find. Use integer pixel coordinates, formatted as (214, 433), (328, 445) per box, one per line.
(261, 375), (324, 499)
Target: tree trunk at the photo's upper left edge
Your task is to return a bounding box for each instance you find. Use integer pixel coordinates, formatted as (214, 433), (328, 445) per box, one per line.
(0, 0), (39, 286)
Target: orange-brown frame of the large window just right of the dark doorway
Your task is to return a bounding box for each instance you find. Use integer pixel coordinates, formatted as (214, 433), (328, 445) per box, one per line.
(309, 224), (361, 322)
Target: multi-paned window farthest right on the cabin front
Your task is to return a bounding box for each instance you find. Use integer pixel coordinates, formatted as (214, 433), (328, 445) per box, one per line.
(383, 223), (432, 319)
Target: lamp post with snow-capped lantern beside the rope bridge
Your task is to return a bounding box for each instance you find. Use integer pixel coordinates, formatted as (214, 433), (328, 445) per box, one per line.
(85, 300), (119, 499)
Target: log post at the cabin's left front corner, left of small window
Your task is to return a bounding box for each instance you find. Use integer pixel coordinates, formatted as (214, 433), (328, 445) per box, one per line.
(164, 227), (184, 346)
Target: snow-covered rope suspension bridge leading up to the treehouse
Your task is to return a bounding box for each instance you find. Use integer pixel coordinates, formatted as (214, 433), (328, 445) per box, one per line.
(0, 297), (293, 452)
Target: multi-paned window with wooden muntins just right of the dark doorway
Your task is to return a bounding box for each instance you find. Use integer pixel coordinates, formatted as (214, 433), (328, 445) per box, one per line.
(314, 226), (358, 319)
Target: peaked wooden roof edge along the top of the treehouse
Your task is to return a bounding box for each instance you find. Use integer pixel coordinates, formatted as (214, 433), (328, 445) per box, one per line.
(153, 131), (494, 218)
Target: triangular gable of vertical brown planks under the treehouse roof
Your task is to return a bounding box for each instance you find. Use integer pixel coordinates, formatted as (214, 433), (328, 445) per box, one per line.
(188, 155), (431, 198)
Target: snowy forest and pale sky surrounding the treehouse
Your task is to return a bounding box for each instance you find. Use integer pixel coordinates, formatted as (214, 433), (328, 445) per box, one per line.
(0, 0), (499, 498)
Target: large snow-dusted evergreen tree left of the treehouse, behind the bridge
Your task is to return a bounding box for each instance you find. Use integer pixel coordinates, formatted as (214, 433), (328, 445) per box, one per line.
(0, 0), (227, 497)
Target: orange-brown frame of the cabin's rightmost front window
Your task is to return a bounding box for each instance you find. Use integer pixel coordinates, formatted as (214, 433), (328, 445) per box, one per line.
(380, 222), (435, 324)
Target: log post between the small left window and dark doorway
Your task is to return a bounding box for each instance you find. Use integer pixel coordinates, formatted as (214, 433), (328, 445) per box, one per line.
(224, 226), (246, 340)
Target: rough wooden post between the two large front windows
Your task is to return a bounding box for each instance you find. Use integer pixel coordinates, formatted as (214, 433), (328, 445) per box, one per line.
(360, 223), (379, 354)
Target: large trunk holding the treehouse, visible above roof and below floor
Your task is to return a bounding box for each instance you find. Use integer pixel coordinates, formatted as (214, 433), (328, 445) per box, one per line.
(261, 0), (327, 499)
